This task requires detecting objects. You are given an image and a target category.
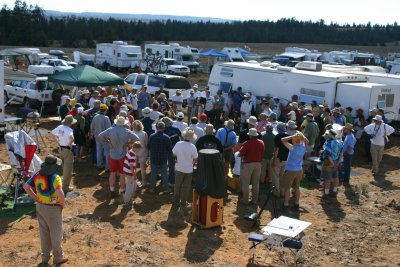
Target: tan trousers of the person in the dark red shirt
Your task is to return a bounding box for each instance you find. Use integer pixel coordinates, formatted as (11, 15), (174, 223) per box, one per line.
(240, 162), (261, 204)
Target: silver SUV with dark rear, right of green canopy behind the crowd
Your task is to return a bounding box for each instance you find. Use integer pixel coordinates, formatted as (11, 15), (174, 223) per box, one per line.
(125, 73), (192, 99)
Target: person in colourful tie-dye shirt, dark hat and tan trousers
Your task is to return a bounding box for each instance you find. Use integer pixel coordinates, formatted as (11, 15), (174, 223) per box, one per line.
(24, 155), (68, 265)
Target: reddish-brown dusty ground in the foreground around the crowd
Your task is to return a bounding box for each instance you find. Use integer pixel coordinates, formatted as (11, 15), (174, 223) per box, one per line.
(0, 103), (400, 266)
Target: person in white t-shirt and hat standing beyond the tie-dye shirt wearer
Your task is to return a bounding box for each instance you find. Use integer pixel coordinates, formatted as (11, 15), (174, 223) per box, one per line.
(51, 115), (76, 193)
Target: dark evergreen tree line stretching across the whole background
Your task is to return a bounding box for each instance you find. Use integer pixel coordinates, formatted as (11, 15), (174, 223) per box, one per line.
(0, 0), (400, 47)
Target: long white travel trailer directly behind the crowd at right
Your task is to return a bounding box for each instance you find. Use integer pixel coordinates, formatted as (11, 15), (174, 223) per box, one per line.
(208, 61), (400, 122)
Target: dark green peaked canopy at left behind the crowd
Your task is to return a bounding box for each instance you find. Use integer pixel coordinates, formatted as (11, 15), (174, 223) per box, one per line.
(49, 65), (124, 87)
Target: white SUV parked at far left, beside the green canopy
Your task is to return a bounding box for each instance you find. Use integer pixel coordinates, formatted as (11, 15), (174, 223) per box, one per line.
(4, 77), (64, 113)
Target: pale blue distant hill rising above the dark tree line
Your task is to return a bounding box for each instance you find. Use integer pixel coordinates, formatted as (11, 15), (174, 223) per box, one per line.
(45, 10), (228, 23)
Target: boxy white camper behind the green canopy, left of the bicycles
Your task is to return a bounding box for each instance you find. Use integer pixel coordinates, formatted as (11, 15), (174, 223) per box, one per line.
(96, 41), (142, 70)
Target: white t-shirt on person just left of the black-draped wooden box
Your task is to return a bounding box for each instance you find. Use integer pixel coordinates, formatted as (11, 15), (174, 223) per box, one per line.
(172, 141), (198, 173)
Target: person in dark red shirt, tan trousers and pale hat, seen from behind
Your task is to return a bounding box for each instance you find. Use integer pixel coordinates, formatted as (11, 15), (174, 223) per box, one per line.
(239, 128), (264, 205)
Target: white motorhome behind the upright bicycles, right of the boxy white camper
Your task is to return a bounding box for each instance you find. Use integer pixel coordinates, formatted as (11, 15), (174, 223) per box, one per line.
(144, 43), (199, 72)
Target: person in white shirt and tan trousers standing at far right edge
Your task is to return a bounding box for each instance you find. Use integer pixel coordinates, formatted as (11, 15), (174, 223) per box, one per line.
(364, 115), (394, 174)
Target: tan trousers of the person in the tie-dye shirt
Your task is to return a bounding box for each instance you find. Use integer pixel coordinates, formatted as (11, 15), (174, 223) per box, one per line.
(36, 203), (64, 262)
